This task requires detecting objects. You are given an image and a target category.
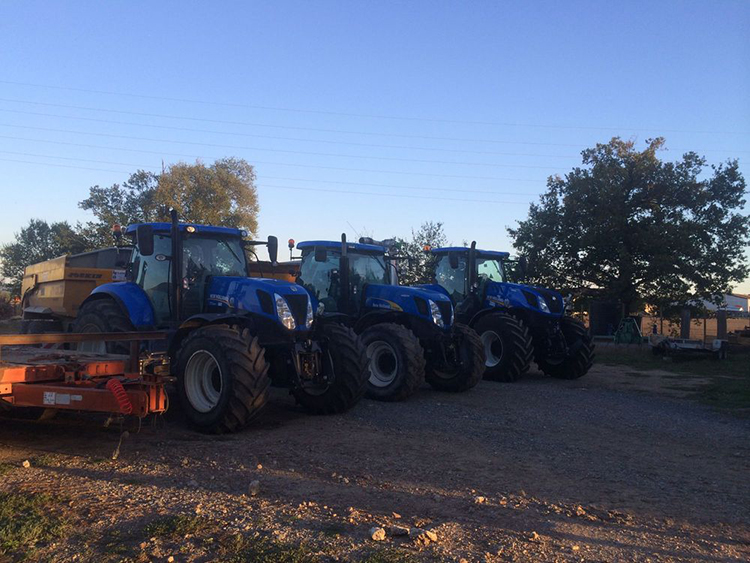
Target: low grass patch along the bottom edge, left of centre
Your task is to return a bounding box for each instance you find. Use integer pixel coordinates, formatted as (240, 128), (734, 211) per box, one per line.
(218, 534), (320, 563)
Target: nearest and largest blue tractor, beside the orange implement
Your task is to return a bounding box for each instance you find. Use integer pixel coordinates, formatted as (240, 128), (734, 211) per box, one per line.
(64, 213), (368, 433)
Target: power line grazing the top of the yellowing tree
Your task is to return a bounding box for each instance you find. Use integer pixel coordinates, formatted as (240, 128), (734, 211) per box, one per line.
(0, 135), (545, 182)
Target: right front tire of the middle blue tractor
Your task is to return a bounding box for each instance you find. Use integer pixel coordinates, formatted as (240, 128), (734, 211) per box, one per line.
(426, 323), (484, 393)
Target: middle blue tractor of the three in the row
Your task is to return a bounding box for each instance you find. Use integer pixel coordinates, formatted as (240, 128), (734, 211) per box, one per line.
(290, 235), (484, 401)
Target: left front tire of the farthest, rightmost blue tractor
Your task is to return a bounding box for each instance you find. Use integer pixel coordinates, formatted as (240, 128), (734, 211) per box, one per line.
(474, 312), (534, 382)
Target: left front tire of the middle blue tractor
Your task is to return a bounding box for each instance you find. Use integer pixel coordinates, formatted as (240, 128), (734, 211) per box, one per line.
(360, 323), (425, 401)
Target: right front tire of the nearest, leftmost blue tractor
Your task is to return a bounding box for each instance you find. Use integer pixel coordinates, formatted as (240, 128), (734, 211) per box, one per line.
(292, 323), (370, 414)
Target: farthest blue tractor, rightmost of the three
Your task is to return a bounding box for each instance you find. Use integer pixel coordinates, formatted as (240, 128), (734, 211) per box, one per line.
(426, 242), (594, 381)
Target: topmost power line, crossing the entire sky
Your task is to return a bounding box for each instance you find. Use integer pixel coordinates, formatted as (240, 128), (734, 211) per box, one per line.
(0, 80), (750, 135)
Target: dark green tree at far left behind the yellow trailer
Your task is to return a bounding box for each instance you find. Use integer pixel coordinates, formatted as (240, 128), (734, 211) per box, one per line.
(0, 219), (89, 295)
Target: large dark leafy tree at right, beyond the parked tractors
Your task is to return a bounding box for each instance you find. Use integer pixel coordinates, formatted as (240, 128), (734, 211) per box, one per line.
(508, 138), (750, 312)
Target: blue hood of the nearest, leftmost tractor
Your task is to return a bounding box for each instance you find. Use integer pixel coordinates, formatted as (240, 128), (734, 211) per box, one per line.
(207, 276), (312, 330)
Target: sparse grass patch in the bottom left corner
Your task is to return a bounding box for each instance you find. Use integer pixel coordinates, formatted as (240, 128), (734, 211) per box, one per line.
(0, 493), (68, 556)
